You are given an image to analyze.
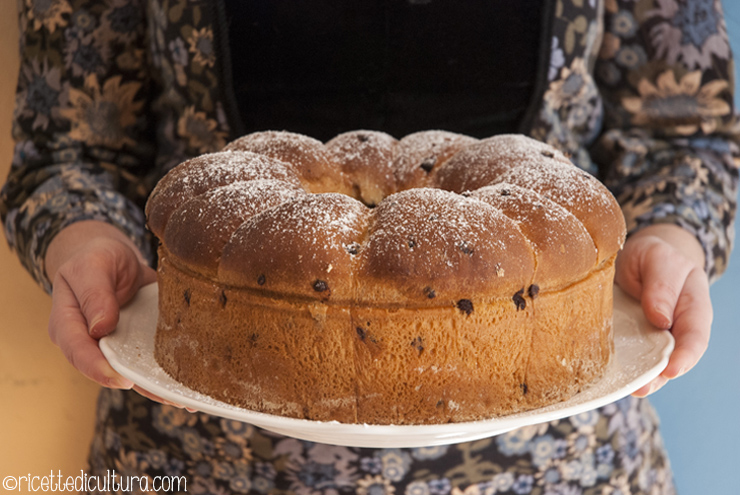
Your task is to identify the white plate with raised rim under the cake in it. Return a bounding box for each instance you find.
[100,284,674,447]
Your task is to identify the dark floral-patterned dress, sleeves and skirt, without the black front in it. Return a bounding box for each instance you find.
[0,0,740,495]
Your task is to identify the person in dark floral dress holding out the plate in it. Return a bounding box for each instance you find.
[0,0,740,495]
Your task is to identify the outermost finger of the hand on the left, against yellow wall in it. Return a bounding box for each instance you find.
[49,275,133,389]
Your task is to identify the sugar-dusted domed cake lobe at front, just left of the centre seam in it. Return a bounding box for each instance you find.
[219,193,369,302]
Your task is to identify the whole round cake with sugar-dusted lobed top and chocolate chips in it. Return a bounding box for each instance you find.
[146,130,625,424]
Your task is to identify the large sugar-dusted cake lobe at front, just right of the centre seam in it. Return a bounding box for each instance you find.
[356,188,535,305]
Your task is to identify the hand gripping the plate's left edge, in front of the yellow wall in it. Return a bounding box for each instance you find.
[46,220,189,407]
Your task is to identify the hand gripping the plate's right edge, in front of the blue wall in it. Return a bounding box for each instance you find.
[615,224,713,397]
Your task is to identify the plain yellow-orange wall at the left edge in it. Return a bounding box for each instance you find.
[0,0,98,476]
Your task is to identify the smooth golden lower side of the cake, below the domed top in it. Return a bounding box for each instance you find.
[155,248,614,424]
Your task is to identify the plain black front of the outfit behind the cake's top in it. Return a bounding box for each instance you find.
[224,0,542,141]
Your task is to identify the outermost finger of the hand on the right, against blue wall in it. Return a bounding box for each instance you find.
[663,268,713,378]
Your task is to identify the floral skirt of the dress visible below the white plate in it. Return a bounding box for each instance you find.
[90,389,675,495]
